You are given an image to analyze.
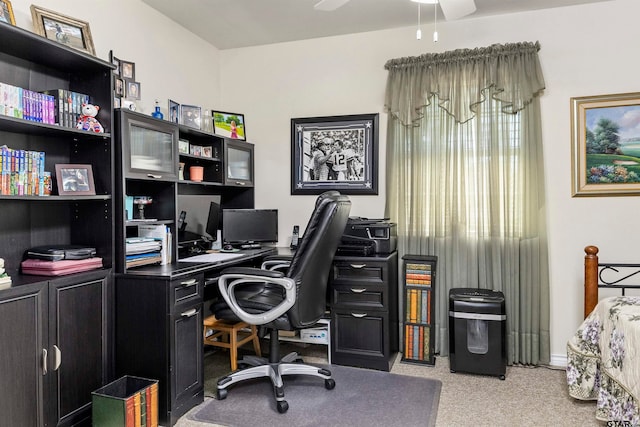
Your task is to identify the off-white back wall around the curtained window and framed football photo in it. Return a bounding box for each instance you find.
[220,0,640,362]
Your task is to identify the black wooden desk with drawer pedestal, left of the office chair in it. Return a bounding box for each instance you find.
[115,248,276,425]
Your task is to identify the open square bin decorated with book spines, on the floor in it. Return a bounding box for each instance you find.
[91,375,158,427]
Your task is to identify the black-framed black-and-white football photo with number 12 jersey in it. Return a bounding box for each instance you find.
[291,113,378,194]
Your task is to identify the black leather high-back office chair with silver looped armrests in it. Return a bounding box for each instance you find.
[212,194,351,413]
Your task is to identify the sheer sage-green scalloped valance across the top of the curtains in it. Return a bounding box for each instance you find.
[385,42,544,125]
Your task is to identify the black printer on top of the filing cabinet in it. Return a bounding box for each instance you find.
[336,217,398,256]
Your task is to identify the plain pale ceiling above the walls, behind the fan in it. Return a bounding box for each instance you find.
[142,0,611,49]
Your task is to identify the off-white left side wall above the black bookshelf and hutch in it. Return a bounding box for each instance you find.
[8,0,220,118]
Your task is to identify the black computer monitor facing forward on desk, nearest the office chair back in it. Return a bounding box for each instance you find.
[222,209,278,245]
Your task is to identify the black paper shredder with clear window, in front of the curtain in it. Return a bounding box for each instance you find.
[449,288,507,380]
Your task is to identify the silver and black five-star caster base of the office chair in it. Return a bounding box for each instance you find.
[216,329,336,414]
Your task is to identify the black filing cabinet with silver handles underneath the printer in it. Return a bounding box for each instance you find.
[328,252,399,371]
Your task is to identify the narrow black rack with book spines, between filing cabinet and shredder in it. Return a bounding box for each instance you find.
[402,255,438,365]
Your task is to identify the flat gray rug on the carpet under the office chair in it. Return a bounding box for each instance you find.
[191,365,442,427]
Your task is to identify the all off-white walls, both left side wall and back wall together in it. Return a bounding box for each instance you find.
[7,0,640,359]
